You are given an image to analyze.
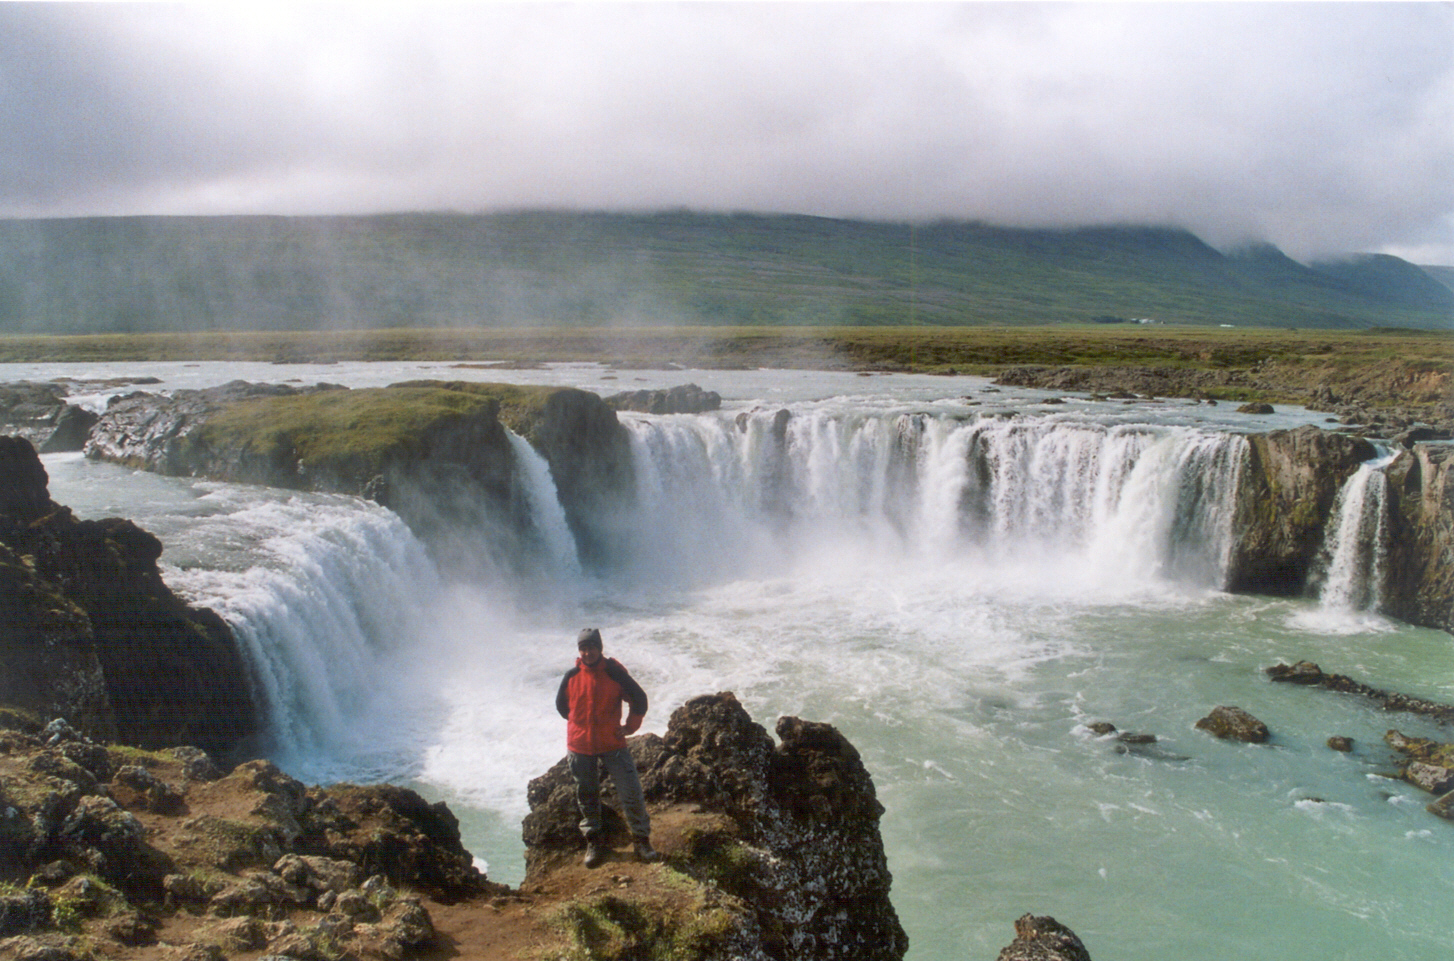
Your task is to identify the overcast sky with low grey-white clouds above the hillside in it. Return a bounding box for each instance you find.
[0,1,1454,263]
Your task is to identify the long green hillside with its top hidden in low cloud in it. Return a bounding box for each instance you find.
[0,212,1454,333]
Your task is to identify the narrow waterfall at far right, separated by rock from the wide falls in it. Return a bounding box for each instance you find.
[1314,454,1393,611]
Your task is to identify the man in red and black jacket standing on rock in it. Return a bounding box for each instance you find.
[555,628,657,868]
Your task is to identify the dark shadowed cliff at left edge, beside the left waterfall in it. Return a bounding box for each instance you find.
[0,438,257,752]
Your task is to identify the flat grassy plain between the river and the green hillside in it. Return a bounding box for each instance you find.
[0,324,1454,372]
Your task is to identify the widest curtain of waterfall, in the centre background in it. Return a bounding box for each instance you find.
[613,410,1246,587]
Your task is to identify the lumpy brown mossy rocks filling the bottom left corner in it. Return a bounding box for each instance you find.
[0,721,507,960]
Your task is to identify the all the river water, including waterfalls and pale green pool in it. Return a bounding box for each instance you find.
[14,363,1454,961]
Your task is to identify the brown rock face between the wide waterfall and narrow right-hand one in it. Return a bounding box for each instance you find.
[1226,426,1377,596]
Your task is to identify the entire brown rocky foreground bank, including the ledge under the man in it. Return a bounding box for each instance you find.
[0,693,936,961]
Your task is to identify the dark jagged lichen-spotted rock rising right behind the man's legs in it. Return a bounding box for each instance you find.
[523,693,907,961]
